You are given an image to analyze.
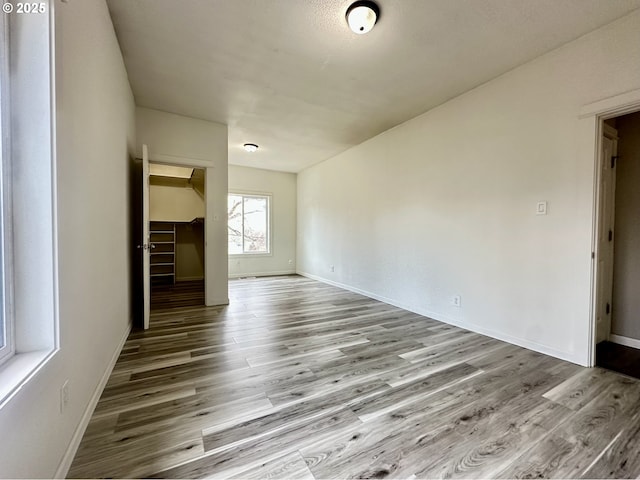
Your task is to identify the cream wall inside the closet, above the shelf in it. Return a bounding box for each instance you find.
[149,185,204,222]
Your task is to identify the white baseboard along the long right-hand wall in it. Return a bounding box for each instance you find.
[297,271,589,367]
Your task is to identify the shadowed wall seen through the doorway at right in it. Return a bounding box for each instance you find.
[611,113,640,340]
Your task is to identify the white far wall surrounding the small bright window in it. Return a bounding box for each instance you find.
[229,165,296,277]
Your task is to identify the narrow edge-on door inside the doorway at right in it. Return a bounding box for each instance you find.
[596,129,616,343]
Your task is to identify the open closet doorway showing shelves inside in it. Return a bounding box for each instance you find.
[149,163,206,311]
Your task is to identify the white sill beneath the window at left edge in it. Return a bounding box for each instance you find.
[0,350,55,409]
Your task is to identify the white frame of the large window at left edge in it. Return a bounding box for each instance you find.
[0,0,60,409]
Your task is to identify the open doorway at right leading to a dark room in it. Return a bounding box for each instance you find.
[595,112,640,378]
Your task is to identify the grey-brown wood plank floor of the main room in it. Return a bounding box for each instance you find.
[69,276,640,479]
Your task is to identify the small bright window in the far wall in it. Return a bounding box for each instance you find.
[228,193,271,255]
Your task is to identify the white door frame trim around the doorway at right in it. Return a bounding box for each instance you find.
[579,89,640,367]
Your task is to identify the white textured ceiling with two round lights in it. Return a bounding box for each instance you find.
[108,0,640,172]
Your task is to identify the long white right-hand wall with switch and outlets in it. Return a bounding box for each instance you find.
[297,11,640,364]
